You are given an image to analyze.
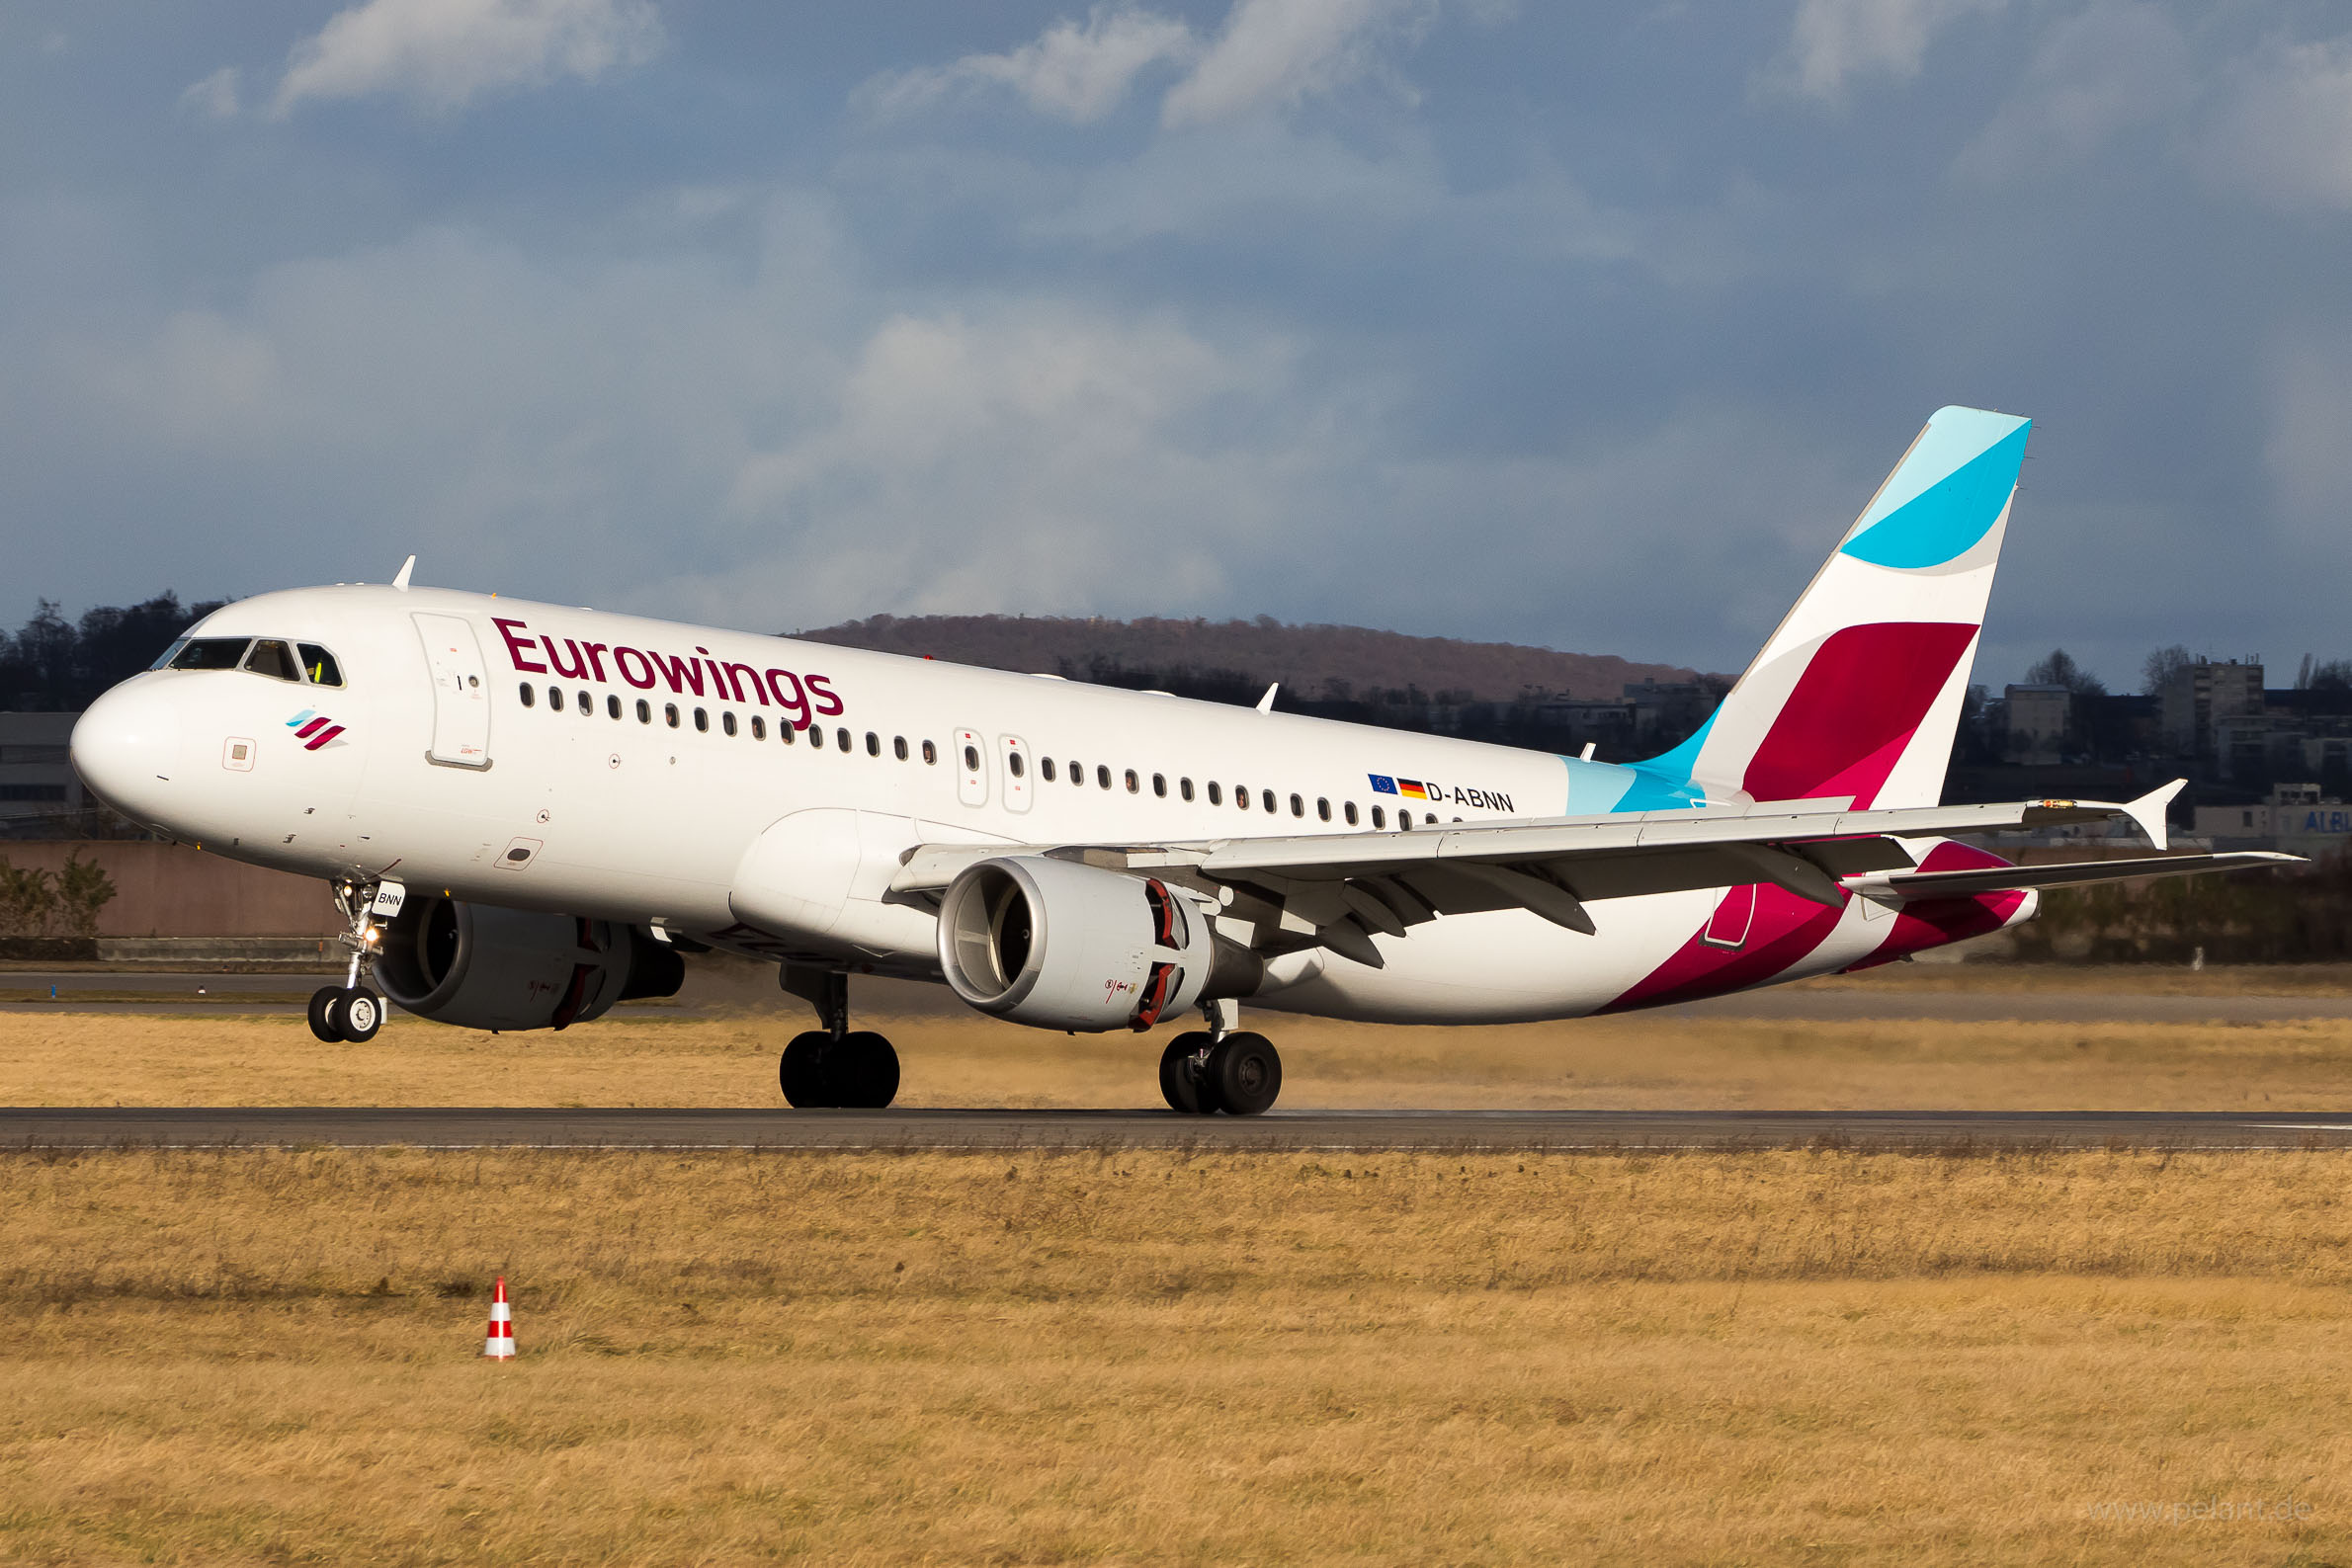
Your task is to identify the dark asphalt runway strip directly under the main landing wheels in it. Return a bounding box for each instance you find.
[0,1105,2352,1154]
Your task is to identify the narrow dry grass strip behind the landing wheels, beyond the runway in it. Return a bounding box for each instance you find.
[0,1013,2352,1110]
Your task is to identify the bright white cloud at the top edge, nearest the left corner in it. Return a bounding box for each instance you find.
[271,0,663,116]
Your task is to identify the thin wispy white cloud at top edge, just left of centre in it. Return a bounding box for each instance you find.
[861,5,1200,124]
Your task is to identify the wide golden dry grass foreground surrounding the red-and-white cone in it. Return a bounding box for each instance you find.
[0,1149,2352,1563]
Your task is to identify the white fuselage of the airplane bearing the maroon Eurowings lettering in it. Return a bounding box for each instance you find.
[75,585,1984,1023]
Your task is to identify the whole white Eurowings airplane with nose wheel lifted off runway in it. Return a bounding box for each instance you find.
[73,407,2296,1114]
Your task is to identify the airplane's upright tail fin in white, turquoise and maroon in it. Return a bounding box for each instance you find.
[1637,409,2032,806]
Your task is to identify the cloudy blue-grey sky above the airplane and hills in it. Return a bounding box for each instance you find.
[0,0,2352,689]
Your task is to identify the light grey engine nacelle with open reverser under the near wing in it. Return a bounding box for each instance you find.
[939,856,1216,1030]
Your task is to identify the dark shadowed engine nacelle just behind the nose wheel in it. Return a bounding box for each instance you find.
[377,893,687,1030]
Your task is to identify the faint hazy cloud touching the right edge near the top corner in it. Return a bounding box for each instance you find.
[2199,38,2352,211]
